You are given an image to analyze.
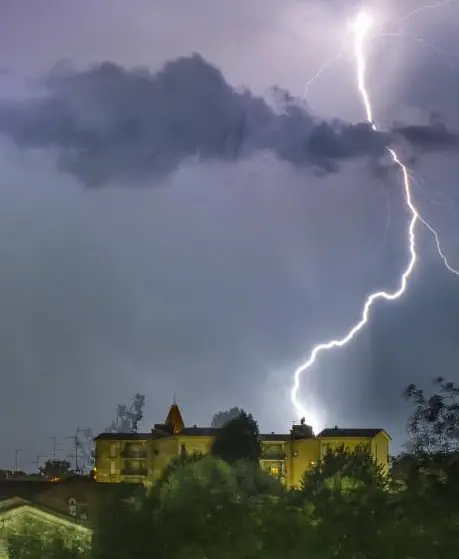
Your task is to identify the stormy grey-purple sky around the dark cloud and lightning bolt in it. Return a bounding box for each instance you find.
[0,0,459,468]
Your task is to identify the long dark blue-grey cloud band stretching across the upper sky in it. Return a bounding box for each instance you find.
[0,55,454,185]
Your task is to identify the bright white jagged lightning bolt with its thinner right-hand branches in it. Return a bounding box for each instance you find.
[290,7,459,424]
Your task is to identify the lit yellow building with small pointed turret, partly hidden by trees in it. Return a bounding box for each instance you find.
[95,404,390,487]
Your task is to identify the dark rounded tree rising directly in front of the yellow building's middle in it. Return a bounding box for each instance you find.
[212,411,261,464]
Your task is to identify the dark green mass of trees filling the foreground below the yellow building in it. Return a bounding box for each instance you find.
[10,390,459,559]
